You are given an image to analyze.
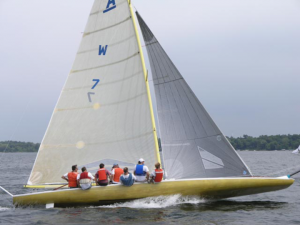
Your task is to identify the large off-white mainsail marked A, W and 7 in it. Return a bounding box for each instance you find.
[28,0,159,184]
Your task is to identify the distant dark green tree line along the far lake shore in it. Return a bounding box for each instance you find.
[0,134,300,152]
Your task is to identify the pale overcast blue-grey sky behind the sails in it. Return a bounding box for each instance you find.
[0,0,300,142]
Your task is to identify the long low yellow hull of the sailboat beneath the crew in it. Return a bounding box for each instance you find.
[13,177,294,206]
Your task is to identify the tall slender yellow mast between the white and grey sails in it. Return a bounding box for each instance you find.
[128,0,161,164]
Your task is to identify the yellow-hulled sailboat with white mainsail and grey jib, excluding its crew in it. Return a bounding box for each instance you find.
[1,0,294,206]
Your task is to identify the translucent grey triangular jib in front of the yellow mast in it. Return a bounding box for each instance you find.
[137,13,251,179]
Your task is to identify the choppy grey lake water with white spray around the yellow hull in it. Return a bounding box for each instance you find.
[0,151,300,225]
